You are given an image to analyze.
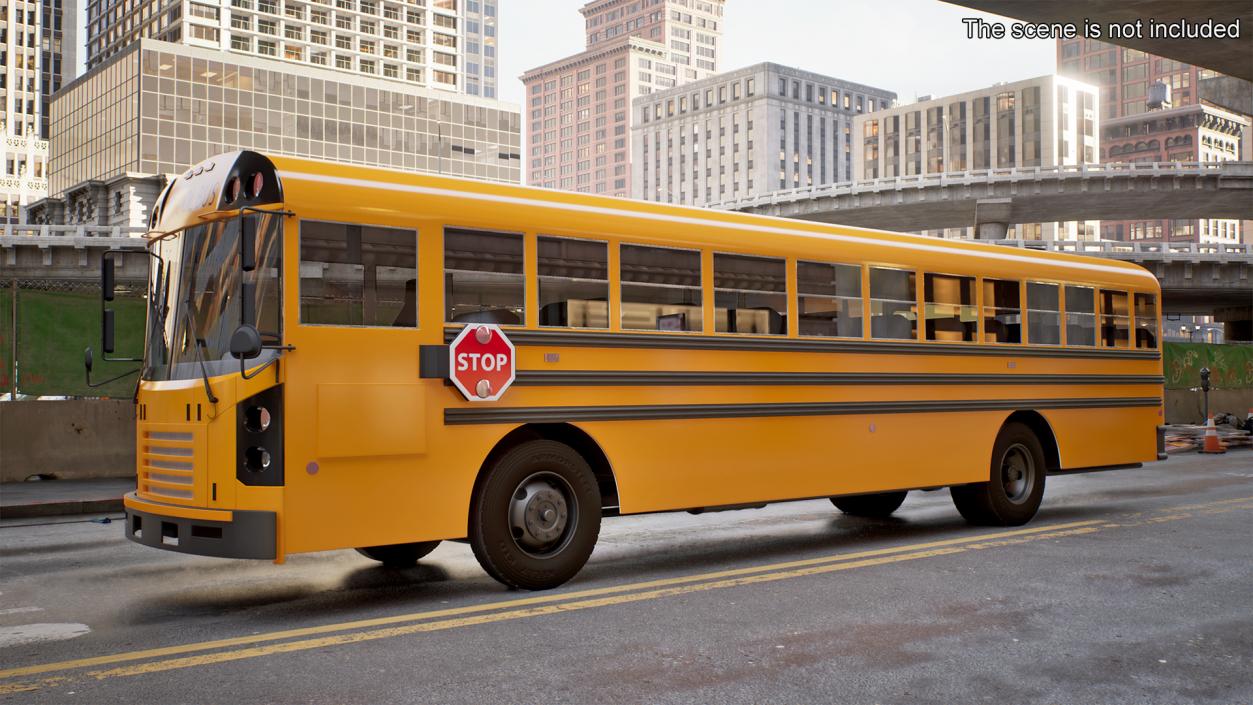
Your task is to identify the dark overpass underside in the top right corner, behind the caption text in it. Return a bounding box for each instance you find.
[946,0,1253,80]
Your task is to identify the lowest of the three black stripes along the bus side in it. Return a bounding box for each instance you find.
[444,397,1162,426]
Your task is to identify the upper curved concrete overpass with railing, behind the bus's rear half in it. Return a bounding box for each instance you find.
[713,162,1253,239]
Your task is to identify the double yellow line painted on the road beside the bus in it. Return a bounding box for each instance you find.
[0,497,1253,694]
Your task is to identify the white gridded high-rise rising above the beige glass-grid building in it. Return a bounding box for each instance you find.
[86,0,483,95]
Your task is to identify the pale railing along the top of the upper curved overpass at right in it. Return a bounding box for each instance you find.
[708,162,1253,210]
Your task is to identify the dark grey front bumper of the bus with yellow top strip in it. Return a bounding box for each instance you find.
[123,492,278,560]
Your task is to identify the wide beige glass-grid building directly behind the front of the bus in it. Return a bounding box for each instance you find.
[31,39,521,227]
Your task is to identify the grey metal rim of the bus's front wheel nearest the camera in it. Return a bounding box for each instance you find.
[509,472,579,558]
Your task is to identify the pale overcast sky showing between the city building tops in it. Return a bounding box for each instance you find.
[497,0,1056,104]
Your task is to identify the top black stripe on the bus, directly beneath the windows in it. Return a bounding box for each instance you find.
[444,327,1162,359]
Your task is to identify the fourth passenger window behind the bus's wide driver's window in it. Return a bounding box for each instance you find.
[713,253,787,336]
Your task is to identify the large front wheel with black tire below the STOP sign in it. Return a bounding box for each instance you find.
[469,441,600,590]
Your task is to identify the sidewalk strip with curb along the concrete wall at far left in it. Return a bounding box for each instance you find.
[0,477,135,518]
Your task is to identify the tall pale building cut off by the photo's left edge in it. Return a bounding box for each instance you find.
[0,0,78,223]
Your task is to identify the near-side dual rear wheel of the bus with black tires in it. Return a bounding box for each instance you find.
[949,423,1048,526]
